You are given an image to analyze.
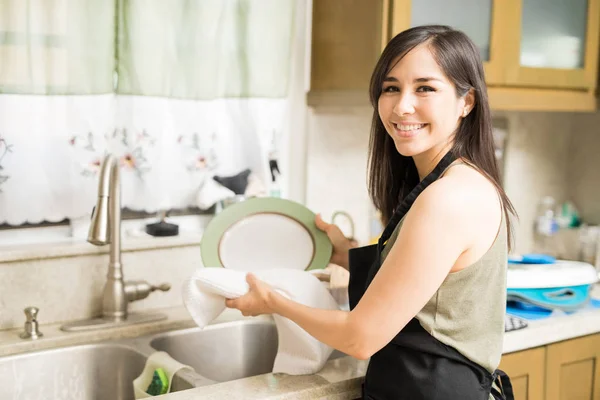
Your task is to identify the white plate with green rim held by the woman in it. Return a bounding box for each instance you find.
[200,197,332,271]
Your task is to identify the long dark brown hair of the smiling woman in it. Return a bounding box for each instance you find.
[368,25,516,248]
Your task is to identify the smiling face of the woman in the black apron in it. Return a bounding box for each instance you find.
[379,44,473,157]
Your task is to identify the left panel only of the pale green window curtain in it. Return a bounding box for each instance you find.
[0,0,116,95]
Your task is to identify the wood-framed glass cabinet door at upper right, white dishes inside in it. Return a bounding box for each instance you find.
[500,0,600,90]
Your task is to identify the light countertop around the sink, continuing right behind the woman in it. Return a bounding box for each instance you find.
[0,292,600,400]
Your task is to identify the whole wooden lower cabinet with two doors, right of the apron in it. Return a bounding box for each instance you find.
[500,334,600,400]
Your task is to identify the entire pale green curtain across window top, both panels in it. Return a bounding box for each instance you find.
[0,0,295,100]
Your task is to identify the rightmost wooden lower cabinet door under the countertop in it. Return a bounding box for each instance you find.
[546,335,600,400]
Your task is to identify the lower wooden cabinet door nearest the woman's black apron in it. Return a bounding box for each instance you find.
[500,347,546,400]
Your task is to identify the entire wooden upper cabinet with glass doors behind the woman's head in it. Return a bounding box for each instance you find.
[309,0,600,111]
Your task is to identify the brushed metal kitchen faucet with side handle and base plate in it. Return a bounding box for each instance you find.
[61,154,171,331]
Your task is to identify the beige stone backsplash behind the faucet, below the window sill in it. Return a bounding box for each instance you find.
[0,244,201,330]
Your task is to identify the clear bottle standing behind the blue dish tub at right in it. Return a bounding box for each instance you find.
[533,196,559,257]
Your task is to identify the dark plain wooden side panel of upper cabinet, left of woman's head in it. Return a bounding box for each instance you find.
[311,0,389,91]
